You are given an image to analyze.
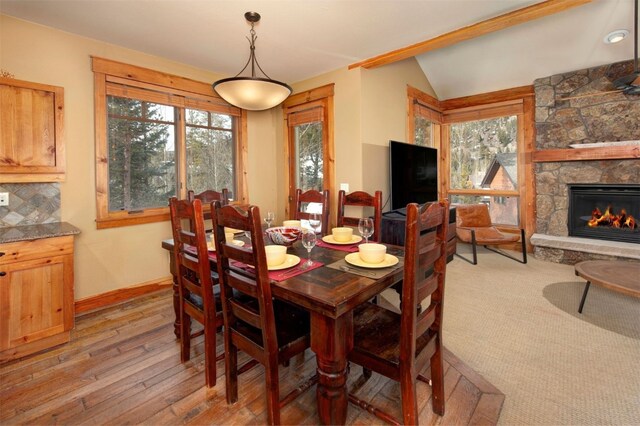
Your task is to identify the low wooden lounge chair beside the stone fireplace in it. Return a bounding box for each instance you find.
[456,204,527,265]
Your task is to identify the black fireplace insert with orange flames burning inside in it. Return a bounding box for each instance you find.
[568,184,640,244]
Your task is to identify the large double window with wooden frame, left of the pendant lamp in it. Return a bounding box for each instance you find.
[93,58,247,228]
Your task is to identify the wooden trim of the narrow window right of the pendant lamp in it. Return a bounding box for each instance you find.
[282,83,338,226]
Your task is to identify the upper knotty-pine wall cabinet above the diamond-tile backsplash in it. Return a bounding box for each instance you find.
[0,77,65,183]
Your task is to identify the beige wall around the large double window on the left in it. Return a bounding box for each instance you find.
[0,15,279,299]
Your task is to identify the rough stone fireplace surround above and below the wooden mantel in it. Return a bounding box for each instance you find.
[531,61,640,264]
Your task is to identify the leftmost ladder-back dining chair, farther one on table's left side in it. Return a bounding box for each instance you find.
[169,197,224,387]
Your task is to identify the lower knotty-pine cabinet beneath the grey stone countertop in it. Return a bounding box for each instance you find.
[0,236,74,362]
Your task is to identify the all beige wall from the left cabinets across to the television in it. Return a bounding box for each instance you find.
[0,16,433,299]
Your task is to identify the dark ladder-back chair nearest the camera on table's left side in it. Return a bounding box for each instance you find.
[212,202,317,424]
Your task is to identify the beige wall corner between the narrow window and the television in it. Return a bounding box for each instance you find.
[288,58,435,213]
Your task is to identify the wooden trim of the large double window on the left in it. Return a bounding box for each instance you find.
[92,57,249,229]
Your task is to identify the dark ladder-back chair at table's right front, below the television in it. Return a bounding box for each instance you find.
[349,200,449,425]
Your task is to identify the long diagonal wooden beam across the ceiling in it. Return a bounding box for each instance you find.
[349,0,593,69]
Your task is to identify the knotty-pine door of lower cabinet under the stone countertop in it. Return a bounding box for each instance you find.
[0,256,73,350]
